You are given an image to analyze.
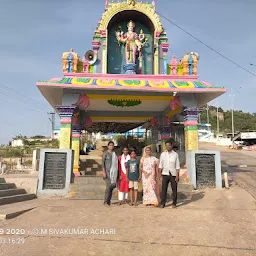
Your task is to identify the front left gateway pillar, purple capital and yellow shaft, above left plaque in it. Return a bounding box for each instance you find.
[56,106,76,149]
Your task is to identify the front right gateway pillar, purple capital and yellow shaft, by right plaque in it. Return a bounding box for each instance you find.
[184,108,200,151]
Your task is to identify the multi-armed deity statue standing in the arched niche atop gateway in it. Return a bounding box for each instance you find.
[116,20,148,64]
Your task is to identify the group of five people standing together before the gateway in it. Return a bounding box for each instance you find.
[102,140,180,208]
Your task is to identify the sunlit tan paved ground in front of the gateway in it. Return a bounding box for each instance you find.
[0,145,256,256]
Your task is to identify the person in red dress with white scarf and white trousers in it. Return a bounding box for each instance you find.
[118,147,130,205]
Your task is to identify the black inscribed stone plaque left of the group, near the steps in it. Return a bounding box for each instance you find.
[43,152,67,189]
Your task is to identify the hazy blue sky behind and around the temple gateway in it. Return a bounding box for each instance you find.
[0,0,256,144]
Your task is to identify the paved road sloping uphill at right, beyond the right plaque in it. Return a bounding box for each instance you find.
[200,143,256,199]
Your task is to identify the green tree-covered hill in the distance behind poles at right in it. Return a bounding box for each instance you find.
[201,106,256,133]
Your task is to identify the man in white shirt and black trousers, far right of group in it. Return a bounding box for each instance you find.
[158,140,180,208]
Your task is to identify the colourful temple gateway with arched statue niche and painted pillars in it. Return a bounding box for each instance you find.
[37,0,226,180]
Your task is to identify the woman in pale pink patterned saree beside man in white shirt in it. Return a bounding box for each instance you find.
[140,146,159,206]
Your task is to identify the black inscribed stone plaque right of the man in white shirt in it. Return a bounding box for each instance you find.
[195,154,216,187]
